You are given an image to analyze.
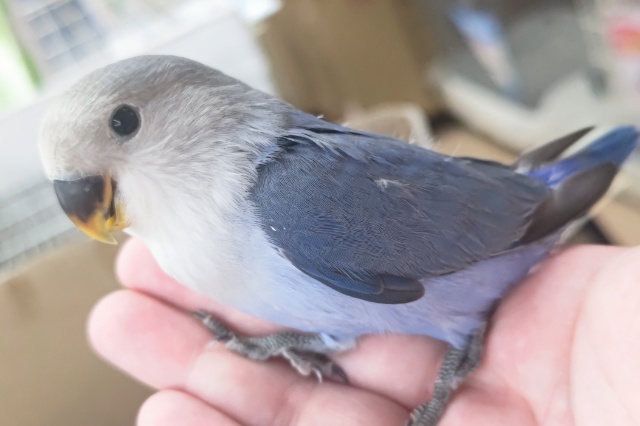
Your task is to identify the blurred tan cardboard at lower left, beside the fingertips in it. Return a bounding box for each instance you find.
[0,241,151,426]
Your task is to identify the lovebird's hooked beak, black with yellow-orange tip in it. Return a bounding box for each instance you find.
[53,176,129,244]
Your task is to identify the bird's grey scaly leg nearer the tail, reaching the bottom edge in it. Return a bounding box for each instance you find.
[406,328,485,426]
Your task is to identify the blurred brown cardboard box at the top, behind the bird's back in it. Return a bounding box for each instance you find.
[256,0,440,120]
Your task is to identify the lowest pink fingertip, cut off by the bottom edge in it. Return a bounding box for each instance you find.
[136,390,240,426]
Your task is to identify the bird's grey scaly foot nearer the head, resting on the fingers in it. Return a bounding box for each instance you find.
[192,311,350,383]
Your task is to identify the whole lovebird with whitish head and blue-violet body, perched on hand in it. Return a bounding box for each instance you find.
[39,56,638,426]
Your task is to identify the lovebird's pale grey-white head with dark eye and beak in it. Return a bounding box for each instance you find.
[39,56,283,243]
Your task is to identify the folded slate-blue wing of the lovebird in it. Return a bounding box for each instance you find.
[246,113,551,303]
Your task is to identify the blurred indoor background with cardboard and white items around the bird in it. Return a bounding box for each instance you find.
[0,0,640,426]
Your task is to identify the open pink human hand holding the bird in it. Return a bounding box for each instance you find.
[90,240,640,426]
